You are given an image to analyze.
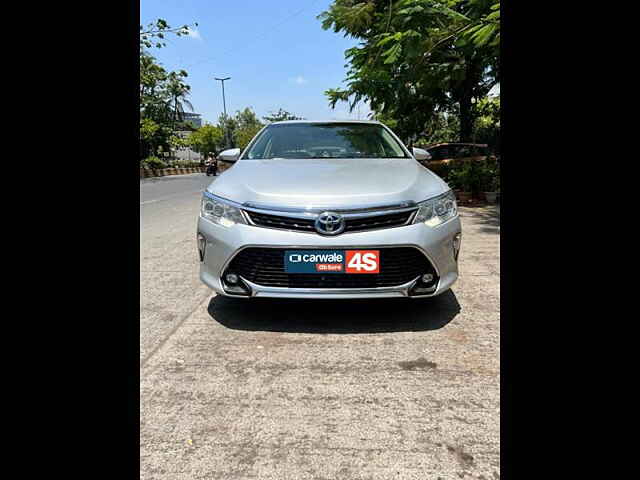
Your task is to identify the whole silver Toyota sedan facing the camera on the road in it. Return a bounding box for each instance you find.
[197,121,461,299]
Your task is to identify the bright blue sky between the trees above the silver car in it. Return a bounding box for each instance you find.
[140,0,370,123]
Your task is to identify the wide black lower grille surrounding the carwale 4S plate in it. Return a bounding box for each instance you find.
[224,247,437,288]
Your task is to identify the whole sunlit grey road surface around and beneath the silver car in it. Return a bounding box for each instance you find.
[140,174,500,480]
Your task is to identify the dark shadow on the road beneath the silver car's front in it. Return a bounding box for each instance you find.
[207,290,460,334]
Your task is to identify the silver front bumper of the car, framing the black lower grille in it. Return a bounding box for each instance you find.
[198,217,461,299]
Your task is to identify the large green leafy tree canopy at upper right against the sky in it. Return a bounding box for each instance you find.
[318,0,500,141]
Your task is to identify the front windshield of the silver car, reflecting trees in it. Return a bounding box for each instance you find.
[242,123,408,160]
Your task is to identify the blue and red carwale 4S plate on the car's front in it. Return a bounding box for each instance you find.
[284,250,380,273]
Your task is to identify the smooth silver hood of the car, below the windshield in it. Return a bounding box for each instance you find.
[207,158,448,208]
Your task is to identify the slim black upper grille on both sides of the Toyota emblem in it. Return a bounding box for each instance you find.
[246,210,415,232]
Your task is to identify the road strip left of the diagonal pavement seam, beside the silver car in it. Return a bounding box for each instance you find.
[140,173,211,364]
